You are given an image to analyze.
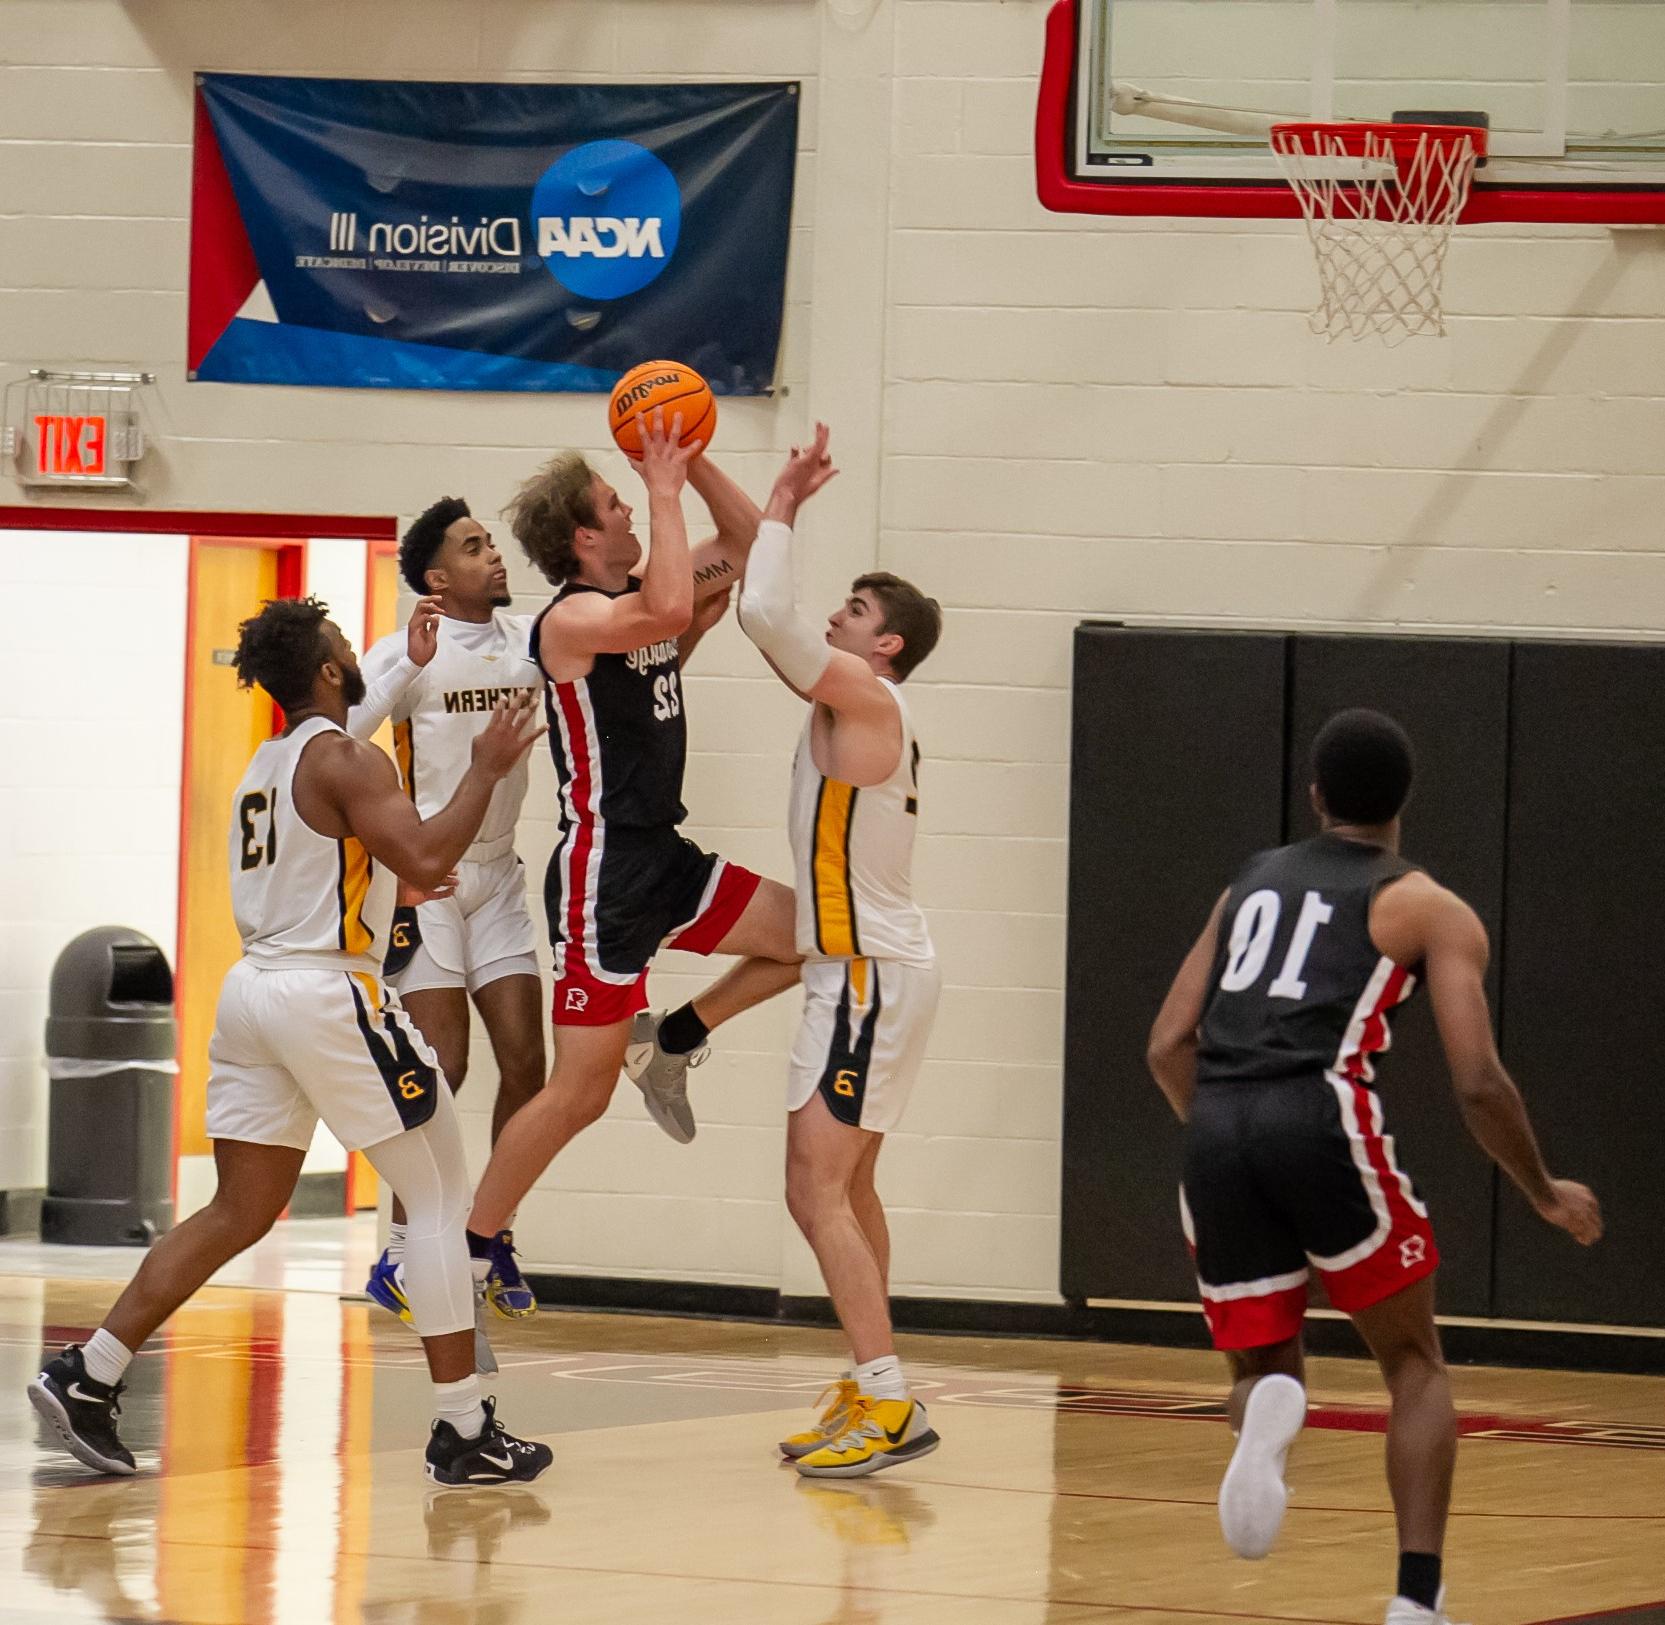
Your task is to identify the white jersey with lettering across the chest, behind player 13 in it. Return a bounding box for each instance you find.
[365,609,543,862]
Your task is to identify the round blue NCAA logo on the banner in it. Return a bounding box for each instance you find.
[531,142,683,300]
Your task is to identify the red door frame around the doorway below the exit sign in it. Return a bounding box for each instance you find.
[0,504,398,1202]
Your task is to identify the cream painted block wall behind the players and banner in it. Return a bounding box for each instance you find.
[0,0,1665,1297]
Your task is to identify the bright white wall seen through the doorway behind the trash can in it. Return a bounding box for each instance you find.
[0,529,188,1190]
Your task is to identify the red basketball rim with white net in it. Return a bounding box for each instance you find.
[1272,122,1485,345]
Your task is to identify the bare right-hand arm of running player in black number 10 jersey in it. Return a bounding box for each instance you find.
[1370,874,1602,1247]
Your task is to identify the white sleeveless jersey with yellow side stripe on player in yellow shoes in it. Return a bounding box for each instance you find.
[788,679,936,964]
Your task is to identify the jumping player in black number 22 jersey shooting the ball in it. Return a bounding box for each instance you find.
[470,415,799,1252]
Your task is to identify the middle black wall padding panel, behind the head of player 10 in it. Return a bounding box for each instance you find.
[1285,636,1510,1315]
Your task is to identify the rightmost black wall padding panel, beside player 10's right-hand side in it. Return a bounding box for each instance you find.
[1497,643,1665,1325]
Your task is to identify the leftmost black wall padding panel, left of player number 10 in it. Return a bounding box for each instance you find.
[1061,624,1287,1299]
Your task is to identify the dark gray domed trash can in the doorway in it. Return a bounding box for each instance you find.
[40,926,178,1247]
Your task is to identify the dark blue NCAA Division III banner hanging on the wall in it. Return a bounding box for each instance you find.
[188,73,799,395]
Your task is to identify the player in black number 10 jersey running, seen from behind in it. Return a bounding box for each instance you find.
[1149,711,1602,1625]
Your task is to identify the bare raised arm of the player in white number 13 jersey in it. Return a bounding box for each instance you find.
[295,693,544,891]
